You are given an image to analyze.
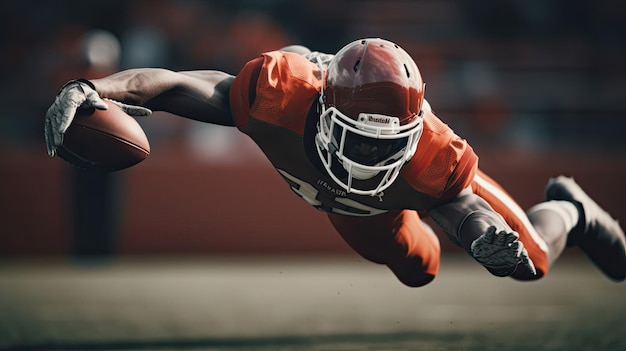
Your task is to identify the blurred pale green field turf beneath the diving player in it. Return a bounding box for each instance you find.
[0,252,626,351]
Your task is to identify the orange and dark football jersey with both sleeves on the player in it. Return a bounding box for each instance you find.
[230,51,478,215]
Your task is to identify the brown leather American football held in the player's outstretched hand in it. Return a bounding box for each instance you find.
[58,101,150,172]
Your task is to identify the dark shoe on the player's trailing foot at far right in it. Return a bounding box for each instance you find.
[545,176,626,281]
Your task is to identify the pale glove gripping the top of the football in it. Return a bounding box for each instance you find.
[44,80,152,157]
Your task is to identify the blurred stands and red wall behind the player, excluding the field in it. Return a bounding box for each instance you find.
[0,0,626,257]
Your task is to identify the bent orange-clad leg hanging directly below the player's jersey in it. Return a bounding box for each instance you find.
[328,210,441,287]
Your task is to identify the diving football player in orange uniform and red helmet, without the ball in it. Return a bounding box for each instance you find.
[45,38,626,287]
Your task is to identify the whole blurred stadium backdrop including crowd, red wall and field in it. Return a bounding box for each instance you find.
[0,0,626,351]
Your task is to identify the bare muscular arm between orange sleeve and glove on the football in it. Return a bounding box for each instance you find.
[91,68,234,126]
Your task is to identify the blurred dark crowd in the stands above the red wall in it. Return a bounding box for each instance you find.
[0,0,626,153]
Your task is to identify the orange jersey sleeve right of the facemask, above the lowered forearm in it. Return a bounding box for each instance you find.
[401,112,478,203]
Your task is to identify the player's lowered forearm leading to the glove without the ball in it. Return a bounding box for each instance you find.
[428,189,512,252]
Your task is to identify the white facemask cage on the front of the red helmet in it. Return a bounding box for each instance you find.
[315,105,423,196]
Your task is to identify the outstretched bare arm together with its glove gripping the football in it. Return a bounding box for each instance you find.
[44,68,234,156]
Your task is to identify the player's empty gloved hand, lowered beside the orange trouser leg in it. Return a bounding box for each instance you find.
[471,226,537,277]
